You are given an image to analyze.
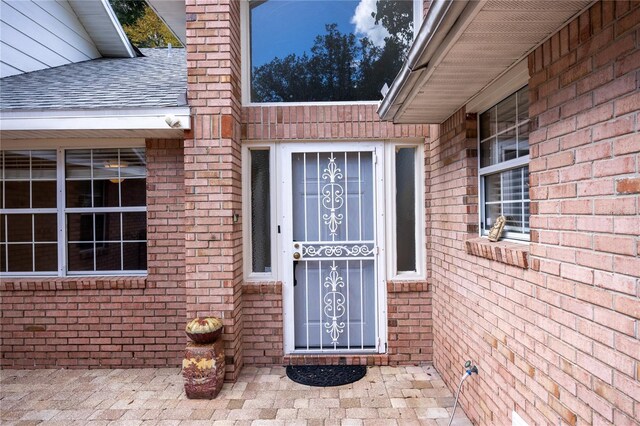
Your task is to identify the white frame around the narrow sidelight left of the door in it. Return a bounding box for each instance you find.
[242,142,281,282]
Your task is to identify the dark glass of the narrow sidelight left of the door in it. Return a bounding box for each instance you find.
[251,150,271,273]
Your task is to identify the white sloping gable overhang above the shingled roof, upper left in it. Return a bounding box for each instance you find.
[69,0,136,58]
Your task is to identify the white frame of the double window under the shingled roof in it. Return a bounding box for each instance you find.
[0,138,148,278]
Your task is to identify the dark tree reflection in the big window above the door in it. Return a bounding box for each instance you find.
[251,0,413,102]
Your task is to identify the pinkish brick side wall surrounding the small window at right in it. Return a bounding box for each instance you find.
[429,1,640,425]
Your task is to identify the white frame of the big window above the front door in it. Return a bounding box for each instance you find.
[240,0,424,106]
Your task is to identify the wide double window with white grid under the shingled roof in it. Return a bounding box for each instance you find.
[0,148,147,276]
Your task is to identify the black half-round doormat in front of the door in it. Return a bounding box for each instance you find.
[287,365,367,387]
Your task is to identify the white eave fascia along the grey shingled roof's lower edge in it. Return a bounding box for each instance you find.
[0,107,191,140]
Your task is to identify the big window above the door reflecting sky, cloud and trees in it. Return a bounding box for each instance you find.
[245,0,421,102]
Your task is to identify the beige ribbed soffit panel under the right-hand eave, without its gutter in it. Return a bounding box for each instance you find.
[379,0,593,123]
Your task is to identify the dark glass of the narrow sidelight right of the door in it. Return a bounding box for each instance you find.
[396,147,416,272]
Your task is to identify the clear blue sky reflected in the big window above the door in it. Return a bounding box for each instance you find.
[251,0,362,67]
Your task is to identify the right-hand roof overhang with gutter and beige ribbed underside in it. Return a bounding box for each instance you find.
[378,0,593,123]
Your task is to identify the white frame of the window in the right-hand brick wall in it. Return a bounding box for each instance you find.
[477,88,531,242]
